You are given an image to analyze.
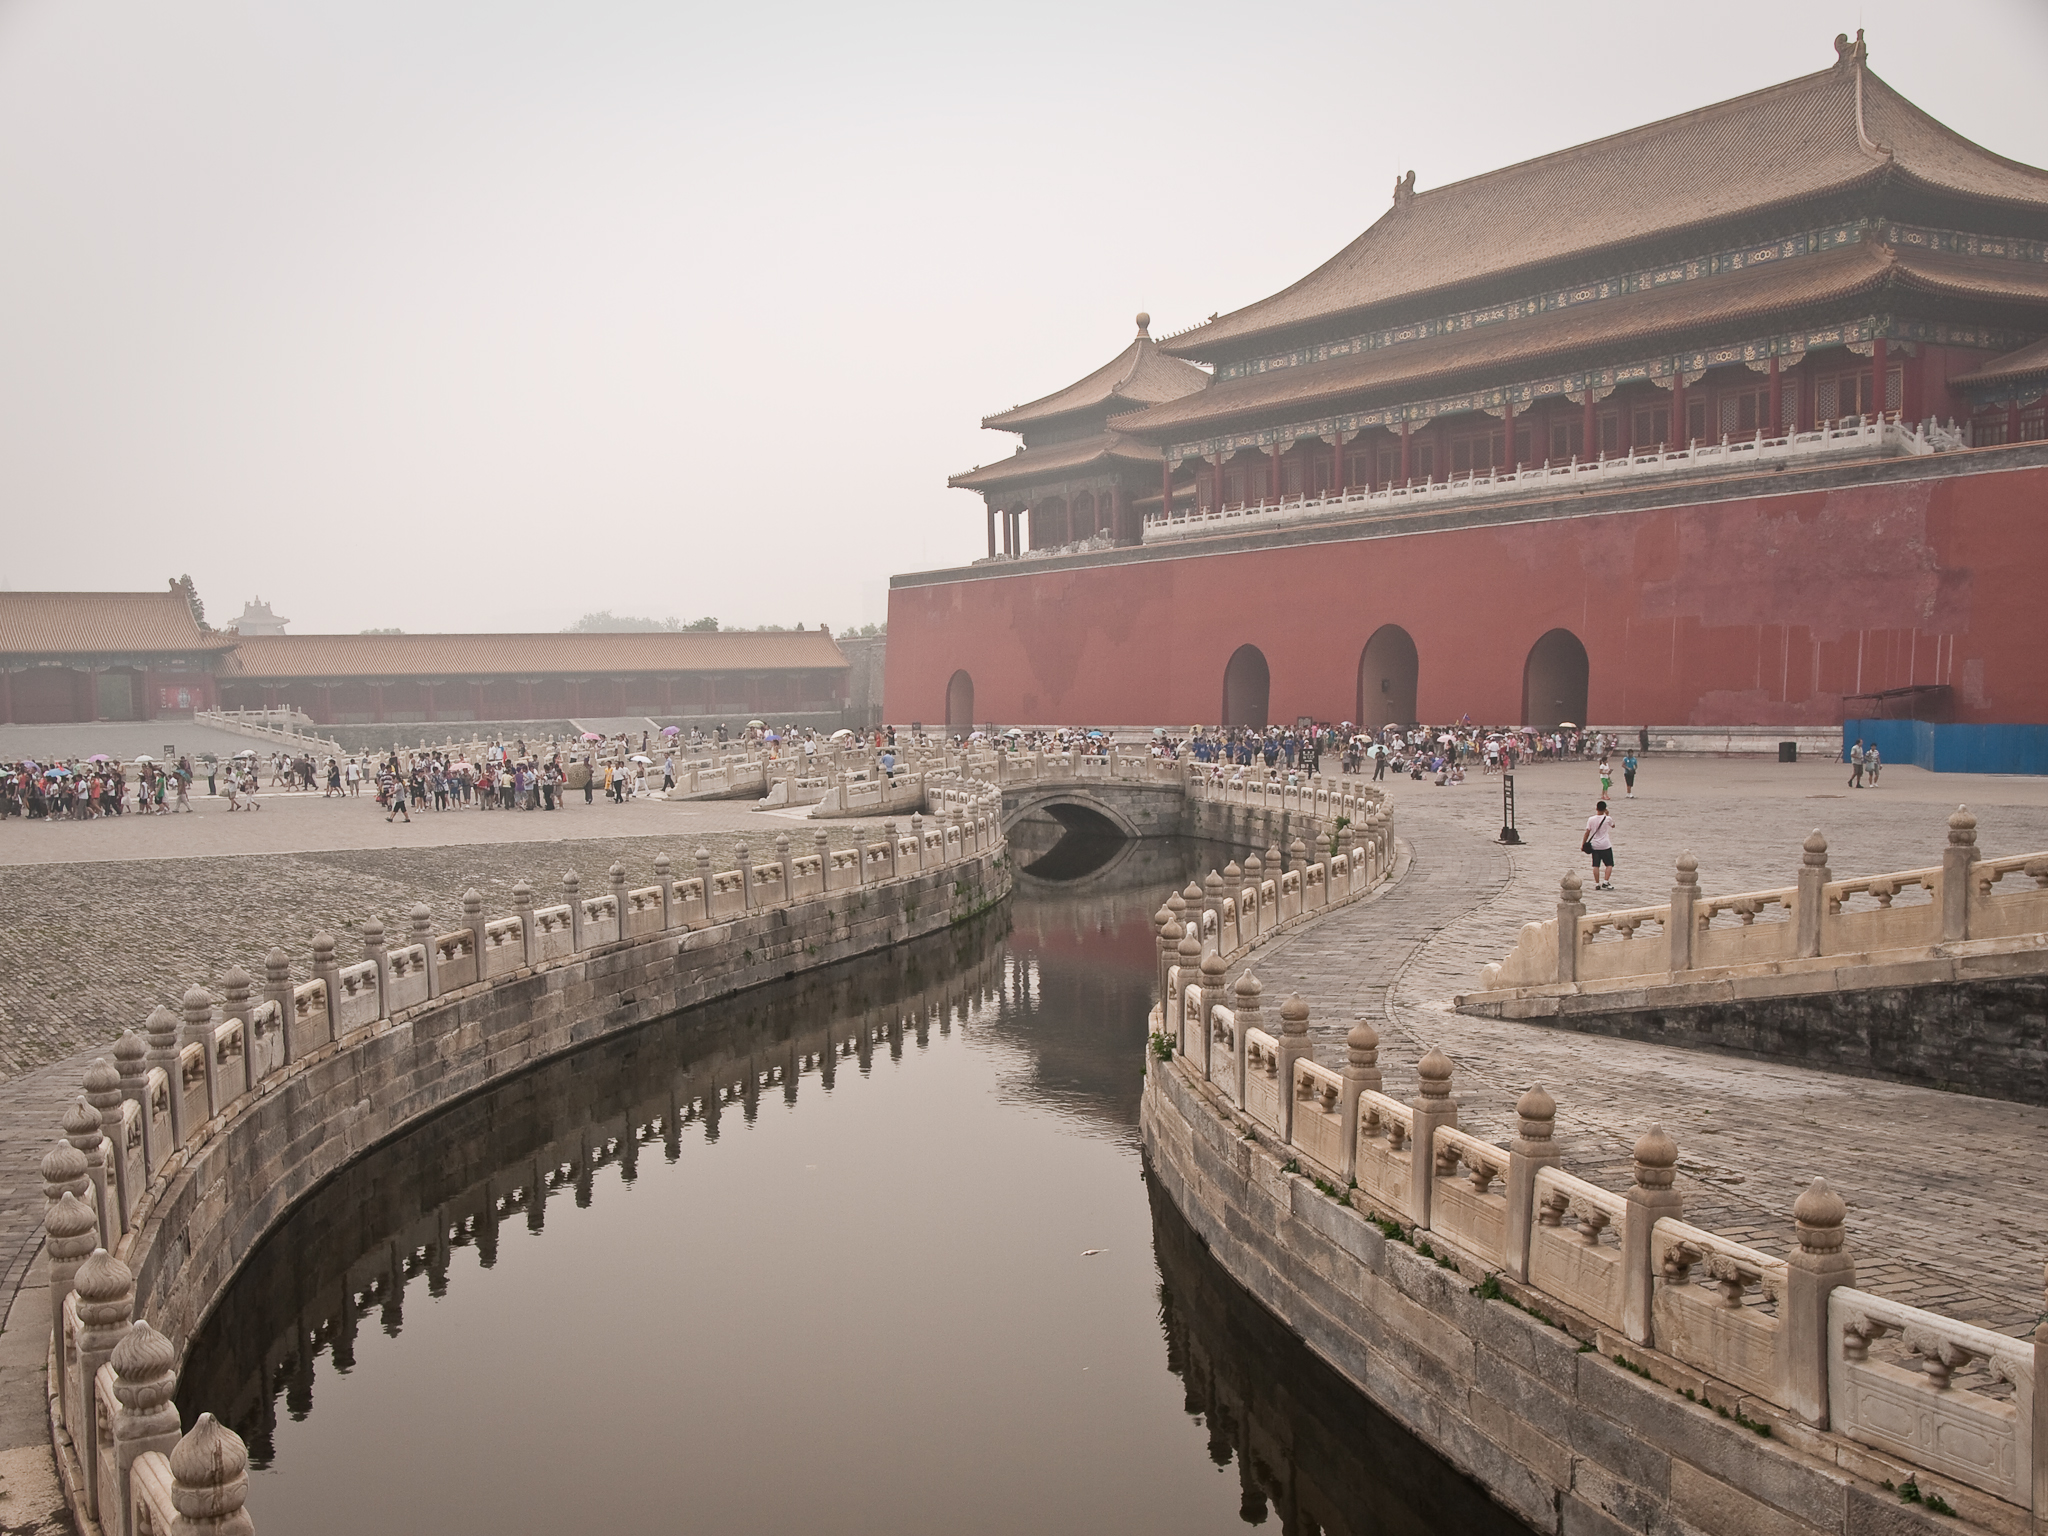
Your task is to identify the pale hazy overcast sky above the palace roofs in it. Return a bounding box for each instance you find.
[0,0,2048,633]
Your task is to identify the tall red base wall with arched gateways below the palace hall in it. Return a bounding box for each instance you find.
[887,465,2048,727]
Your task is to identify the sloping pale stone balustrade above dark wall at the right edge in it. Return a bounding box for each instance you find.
[1458,807,2048,1104]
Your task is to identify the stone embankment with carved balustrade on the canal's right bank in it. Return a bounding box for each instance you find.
[1141,848,2048,1536]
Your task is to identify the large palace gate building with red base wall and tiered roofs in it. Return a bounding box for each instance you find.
[905,35,2048,727]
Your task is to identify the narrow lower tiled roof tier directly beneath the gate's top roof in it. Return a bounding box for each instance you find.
[1116,244,2023,440]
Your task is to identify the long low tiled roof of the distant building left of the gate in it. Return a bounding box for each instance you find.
[221,629,846,678]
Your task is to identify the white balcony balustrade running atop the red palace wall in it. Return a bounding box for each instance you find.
[1138,416,1968,555]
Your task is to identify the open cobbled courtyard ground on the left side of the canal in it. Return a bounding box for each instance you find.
[0,795,897,1079]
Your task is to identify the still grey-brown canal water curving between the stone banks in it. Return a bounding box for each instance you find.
[180,827,1522,1536]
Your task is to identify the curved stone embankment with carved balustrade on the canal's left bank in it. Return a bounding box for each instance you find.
[43,780,1010,1536]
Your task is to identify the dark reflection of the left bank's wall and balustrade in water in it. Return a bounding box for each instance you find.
[178,915,1018,1466]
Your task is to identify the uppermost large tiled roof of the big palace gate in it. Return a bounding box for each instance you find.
[1167,47,2048,356]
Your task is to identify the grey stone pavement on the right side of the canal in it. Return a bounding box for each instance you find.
[1220,758,2048,1333]
